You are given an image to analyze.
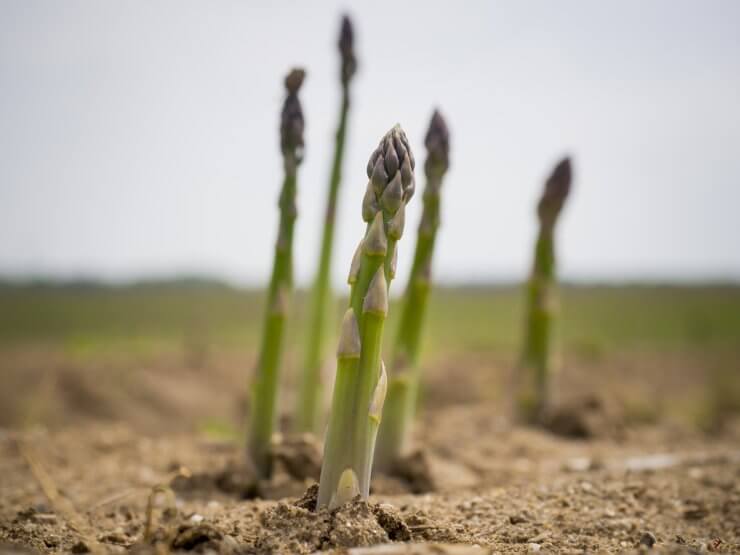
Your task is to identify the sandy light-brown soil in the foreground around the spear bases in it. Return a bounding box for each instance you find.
[0,416,740,555]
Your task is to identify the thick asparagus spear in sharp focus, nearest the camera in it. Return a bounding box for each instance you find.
[318,125,415,507]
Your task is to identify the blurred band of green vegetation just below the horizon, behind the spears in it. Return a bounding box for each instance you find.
[0,281,740,359]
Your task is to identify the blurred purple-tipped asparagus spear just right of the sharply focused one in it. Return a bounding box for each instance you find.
[376,110,450,471]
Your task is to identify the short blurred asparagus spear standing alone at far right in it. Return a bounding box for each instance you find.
[517,158,572,423]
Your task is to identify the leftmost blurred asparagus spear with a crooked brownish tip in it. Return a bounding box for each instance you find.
[247,69,305,477]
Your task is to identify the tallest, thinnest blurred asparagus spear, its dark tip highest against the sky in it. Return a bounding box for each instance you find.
[295,16,357,432]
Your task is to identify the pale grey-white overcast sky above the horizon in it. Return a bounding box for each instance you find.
[0,0,740,285]
